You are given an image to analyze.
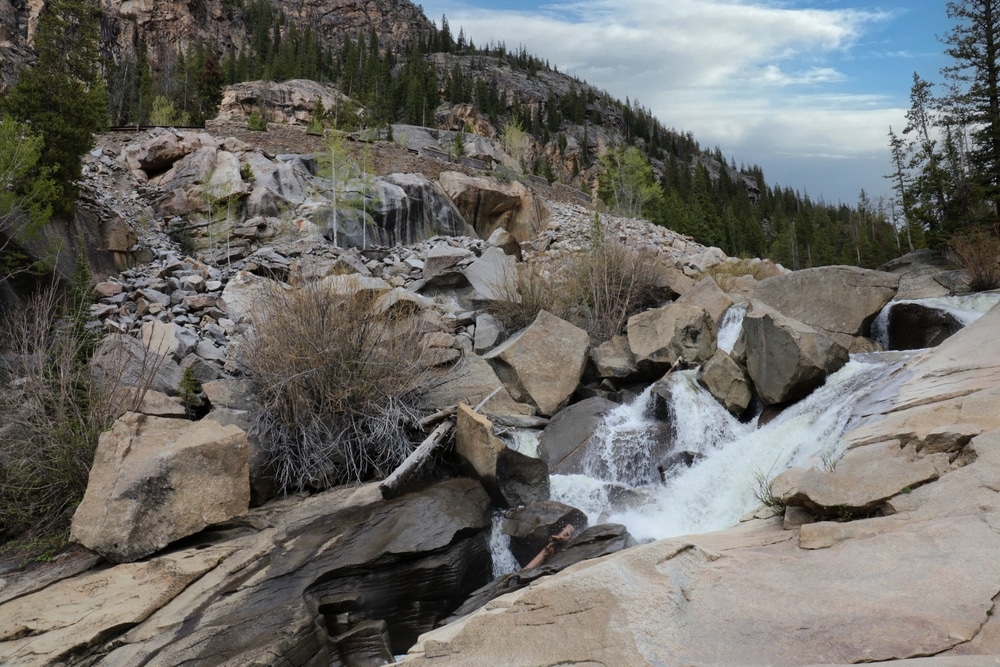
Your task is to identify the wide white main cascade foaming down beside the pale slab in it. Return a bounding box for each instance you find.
[552,354,908,540]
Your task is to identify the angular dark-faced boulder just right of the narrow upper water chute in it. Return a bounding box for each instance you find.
[743,303,849,405]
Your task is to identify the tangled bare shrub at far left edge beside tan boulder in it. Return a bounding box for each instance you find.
[0,289,148,552]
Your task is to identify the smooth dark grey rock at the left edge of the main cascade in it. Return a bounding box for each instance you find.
[538,397,618,475]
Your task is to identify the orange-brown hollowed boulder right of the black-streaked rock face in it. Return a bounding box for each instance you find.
[438,171,544,242]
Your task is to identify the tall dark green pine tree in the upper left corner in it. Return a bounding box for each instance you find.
[0,0,108,216]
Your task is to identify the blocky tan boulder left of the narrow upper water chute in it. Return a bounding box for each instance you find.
[627,303,715,375]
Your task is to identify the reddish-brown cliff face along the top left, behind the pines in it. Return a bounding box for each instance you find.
[0,0,431,88]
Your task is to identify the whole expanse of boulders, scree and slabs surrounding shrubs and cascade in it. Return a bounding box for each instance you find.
[0,124,1000,667]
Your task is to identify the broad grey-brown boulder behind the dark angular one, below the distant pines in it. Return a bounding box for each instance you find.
[754,266,899,348]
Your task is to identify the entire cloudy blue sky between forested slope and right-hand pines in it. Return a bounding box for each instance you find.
[421,0,951,204]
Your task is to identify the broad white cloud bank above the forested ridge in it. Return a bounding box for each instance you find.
[425,0,902,200]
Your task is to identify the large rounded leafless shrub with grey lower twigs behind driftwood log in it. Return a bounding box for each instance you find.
[241,281,429,491]
